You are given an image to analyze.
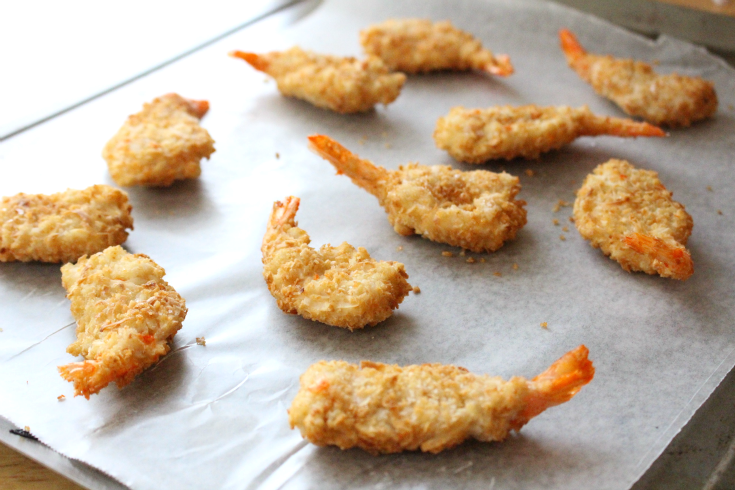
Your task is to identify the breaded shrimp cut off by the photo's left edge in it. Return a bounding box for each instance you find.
[0,185,133,262]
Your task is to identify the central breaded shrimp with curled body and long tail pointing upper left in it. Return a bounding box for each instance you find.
[309,135,526,252]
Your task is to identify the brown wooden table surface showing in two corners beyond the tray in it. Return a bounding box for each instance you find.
[0,0,735,490]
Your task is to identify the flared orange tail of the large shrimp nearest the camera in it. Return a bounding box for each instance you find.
[511,345,595,430]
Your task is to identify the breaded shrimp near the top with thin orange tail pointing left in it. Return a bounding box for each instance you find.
[230,47,406,114]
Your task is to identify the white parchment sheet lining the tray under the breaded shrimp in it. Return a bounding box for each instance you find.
[0,0,735,489]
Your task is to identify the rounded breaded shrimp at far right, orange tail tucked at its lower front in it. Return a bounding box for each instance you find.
[574,160,694,280]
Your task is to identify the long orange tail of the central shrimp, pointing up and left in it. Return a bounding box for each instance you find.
[309,134,388,199]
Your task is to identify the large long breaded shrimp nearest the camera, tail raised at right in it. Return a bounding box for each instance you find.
[288,345,595,454]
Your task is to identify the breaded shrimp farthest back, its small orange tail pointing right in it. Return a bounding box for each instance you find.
[360,19,513,77]
